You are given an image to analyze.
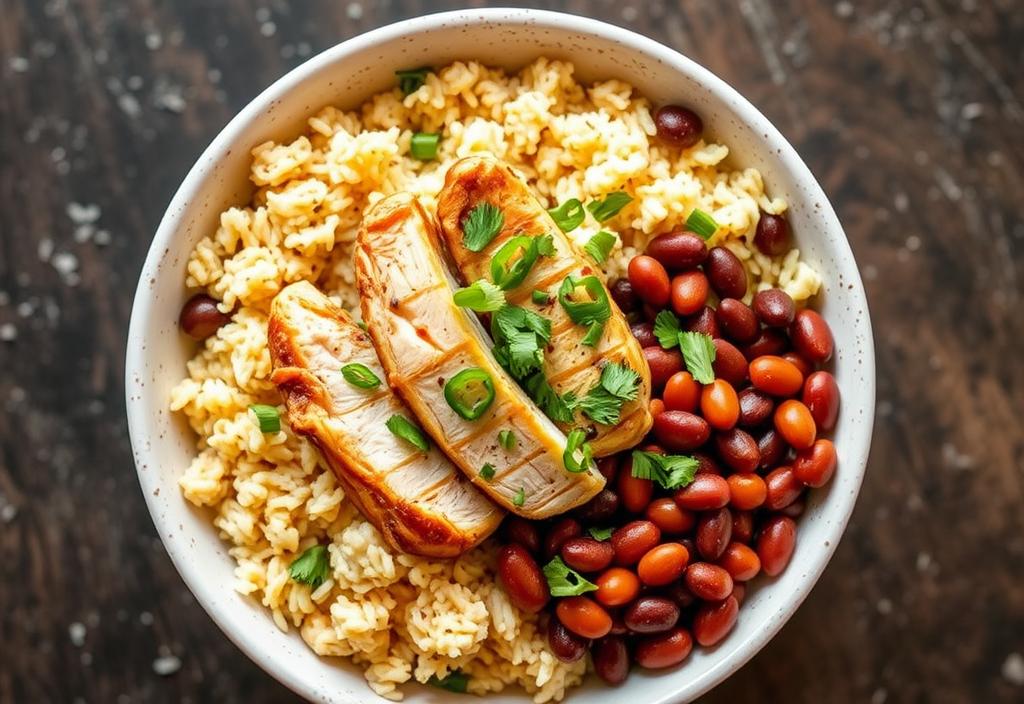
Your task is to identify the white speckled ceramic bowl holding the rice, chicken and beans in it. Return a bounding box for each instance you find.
[126,9,874,704]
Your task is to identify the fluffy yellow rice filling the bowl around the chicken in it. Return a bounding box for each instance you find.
[170,58,820,703]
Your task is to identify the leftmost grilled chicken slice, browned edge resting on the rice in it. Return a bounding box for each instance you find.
[268,281,503,558]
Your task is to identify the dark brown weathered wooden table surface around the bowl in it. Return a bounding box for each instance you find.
[0,0,1024,704]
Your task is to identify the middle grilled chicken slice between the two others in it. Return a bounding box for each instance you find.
[354,193,604,519]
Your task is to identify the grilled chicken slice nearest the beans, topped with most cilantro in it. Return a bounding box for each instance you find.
[437,157,651,456]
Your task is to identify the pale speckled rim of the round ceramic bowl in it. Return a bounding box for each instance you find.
[125,8,874,704]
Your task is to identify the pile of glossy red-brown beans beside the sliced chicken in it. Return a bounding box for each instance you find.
[499,216,839,685]
